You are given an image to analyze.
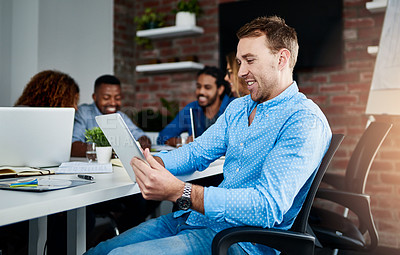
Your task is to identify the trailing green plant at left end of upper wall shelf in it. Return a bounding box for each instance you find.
[134,8,165,49]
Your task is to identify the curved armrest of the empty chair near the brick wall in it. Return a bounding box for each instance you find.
[315,189,379,247]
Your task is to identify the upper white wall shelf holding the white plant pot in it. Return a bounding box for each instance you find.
[136,26,204,39]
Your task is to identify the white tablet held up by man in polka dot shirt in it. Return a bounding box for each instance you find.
[96,113,146,183]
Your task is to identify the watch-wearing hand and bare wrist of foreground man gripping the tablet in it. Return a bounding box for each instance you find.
[131,149,204,214]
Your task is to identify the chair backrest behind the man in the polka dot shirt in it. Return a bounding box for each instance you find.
[291,134,344,233]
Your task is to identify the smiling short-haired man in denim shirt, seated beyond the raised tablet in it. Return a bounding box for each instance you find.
[71,75,151,157]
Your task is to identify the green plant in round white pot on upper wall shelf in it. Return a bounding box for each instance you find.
[173,0,202,26]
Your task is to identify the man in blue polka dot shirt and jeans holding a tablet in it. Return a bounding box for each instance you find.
[87,16,332,255]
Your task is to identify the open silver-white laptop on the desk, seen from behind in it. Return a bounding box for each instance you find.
[0,107,75,167]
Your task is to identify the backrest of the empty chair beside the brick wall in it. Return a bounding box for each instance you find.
[345,122,393,193]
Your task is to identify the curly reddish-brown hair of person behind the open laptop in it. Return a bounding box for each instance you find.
[15,70,79,109]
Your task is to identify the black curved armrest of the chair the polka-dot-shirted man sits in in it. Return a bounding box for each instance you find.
[212,227,315,255]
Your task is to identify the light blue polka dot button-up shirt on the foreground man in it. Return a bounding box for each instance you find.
[157,82,332,254]
